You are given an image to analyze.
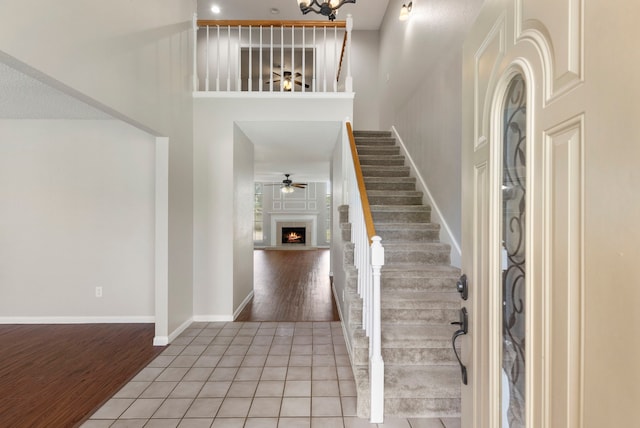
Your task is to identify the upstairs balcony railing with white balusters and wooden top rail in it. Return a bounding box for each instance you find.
[193,15,353,93]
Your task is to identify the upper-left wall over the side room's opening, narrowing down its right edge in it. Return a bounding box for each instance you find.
[0,0,196,335]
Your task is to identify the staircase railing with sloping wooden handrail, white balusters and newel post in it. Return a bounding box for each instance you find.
[345,122,384,423]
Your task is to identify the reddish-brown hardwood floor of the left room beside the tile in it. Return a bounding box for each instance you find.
[0,324,164,428]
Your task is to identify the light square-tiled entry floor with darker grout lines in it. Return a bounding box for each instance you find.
[82,322,460,428]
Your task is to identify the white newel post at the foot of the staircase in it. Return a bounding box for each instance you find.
[369,236,384,424]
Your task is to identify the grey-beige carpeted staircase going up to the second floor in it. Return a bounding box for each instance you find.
[340,131,460,418]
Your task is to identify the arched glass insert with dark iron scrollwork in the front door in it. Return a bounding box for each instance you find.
[502,75,527,428]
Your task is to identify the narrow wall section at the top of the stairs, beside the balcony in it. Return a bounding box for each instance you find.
[351,31,380,130]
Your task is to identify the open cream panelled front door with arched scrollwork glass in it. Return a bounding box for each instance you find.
[462,0,584,428]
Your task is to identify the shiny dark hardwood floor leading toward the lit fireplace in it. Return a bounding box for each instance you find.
[236,249,340,321]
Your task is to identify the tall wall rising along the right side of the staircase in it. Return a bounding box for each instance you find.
[378,0,482,254]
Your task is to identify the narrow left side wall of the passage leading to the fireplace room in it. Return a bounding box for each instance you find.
[233,125,255,313]
